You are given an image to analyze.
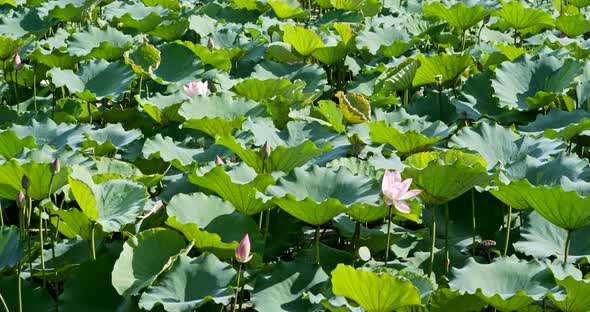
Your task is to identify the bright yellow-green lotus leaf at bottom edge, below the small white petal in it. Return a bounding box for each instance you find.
[332,264,420,312]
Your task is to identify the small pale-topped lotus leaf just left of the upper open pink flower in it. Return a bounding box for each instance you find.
[139,92,186,126]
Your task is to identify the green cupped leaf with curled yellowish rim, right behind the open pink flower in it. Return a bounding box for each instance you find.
[402,150,489,206]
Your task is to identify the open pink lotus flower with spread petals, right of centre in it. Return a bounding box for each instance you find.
[381,170,422,213]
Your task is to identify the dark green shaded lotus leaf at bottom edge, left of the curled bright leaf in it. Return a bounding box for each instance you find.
[59,253,129,312]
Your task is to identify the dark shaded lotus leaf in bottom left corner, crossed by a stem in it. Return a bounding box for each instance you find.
[0,275,55,312]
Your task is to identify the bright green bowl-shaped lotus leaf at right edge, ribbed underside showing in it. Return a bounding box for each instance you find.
[511,178,590,230]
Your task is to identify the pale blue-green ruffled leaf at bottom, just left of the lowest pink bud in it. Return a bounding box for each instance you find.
[139,254,237,312]
